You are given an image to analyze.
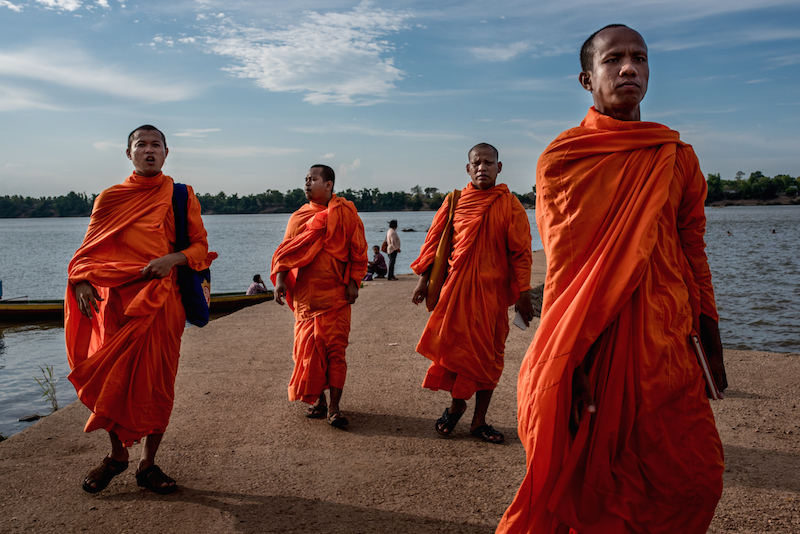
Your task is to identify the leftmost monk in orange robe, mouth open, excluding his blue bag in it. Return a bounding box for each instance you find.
[64,125,217,493]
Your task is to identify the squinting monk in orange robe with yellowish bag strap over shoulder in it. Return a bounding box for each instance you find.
[411,143,533,443]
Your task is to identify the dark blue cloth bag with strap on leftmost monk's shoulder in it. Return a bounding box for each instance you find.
[172,183,211,326]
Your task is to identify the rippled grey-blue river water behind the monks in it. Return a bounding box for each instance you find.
[0,206,800,436]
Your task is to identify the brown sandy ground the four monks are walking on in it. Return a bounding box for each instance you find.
[0,253,800,534]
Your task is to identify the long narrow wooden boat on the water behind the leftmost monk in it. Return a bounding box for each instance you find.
[0,291,274,323]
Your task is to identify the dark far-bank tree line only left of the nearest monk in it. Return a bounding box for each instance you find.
[0,185,535,218]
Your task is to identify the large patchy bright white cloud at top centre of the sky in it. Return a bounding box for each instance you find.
[200,1,410,104]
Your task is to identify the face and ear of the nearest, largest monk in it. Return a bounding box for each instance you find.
[580,27,650,121]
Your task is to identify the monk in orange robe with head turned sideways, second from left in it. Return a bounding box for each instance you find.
[271,165,367,428]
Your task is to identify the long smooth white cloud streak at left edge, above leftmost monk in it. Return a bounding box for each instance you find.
[0,46,197,102]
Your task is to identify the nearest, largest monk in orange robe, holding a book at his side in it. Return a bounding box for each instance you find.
[497,25,727,534]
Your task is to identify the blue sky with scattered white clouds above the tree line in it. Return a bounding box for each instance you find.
[0,0,800,196]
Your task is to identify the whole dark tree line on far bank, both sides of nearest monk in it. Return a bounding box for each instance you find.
[0,171,800,218]
